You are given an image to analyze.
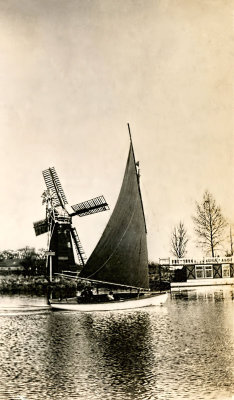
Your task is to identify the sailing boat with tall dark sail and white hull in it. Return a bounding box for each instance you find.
[50,125,168,311]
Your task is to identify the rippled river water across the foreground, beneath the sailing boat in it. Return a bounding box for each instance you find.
[0,286,234,400]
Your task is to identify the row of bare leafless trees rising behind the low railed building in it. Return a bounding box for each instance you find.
[171,191,233,258]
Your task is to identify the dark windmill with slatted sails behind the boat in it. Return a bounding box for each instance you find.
[33,167,109,272]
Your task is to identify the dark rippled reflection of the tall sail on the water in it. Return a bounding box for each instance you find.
[79,312,154,398]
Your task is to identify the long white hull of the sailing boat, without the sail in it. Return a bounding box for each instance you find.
[50,293,168,312]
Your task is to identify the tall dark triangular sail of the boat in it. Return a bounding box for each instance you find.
[80,143,149,289]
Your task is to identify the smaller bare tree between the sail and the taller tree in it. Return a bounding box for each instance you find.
[171,221,188,258]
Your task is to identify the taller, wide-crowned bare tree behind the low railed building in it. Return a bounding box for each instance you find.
[193,191,227,257]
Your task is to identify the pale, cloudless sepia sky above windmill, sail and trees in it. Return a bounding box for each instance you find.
[0,0,234,261]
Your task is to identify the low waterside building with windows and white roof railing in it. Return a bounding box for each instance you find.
[159,257,234,288]
